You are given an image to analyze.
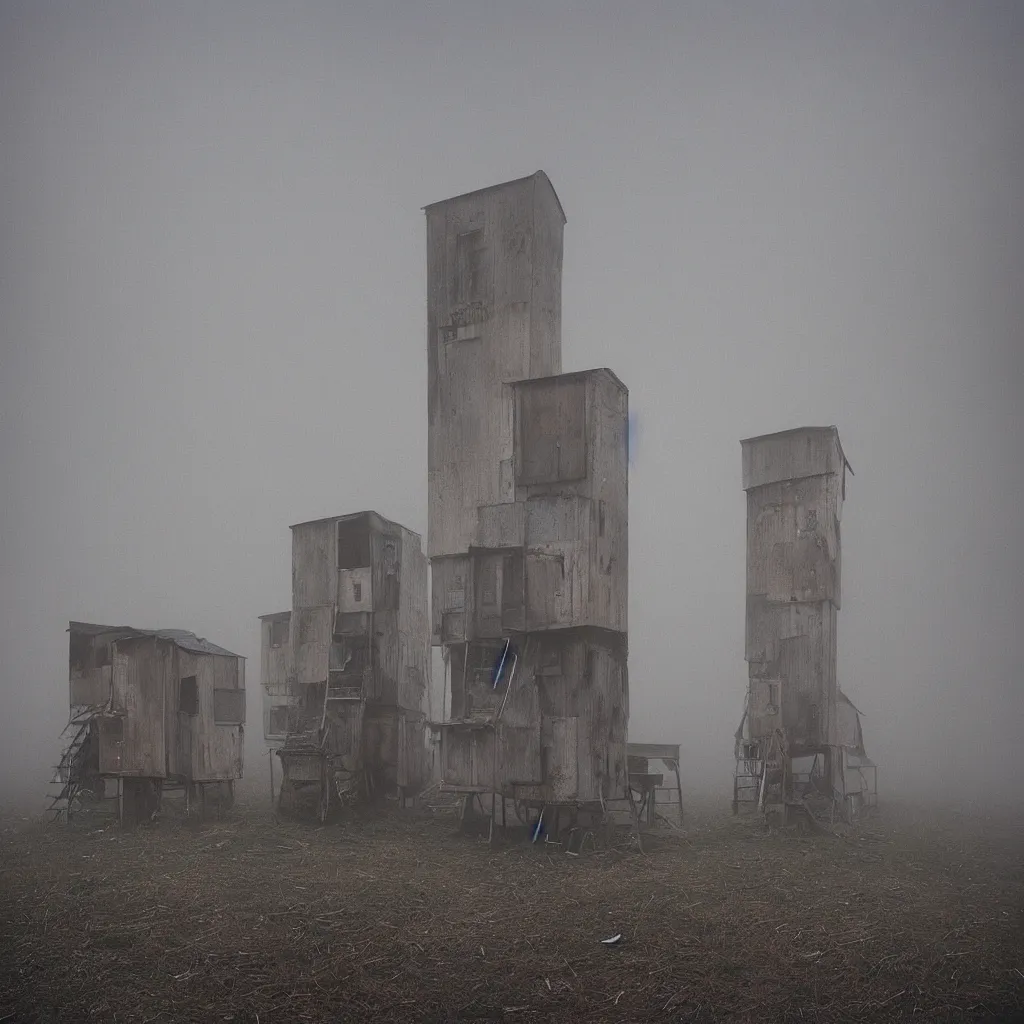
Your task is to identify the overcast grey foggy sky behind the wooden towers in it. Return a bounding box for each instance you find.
[0,0,1024,802]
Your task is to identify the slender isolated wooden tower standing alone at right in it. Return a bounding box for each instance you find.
[734,427,852,816]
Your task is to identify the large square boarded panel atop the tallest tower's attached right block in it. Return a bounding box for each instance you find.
[516,380,587,484]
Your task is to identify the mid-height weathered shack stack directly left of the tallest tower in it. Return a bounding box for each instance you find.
[270,512,430,819]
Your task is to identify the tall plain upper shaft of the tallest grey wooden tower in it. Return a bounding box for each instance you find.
[427,172,564,558]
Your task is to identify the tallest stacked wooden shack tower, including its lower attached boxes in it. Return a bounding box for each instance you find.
[426,171,629,810]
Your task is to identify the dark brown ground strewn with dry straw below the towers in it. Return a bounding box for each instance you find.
[0,807,1024,1024]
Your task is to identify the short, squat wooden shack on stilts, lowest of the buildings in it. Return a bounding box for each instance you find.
[54,622,246,821]
